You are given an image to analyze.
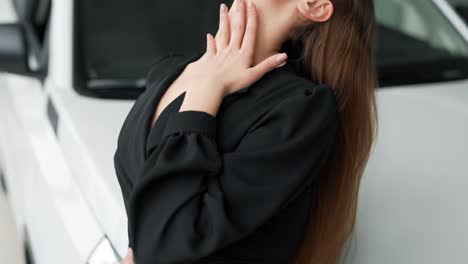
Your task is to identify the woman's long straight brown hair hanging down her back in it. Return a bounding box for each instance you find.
[290,0,378,264]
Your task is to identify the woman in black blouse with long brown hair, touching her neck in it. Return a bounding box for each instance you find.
[114,0,377,264]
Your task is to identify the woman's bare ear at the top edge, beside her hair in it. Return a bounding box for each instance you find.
[297,0,333,22]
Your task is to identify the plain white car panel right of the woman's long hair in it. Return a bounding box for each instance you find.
[346,81,468,264]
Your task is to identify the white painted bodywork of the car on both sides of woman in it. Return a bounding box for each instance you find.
[0,0,468,264]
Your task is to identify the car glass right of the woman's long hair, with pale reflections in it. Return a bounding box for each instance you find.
[376,0,468,87]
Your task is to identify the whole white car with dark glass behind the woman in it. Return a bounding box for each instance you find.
[0,0,468,264]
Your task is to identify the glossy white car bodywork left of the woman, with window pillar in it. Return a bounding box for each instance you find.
[0,1,126,264]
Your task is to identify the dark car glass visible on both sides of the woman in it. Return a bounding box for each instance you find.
[74,0,468,98]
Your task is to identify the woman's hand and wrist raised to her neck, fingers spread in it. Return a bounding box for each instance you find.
[173,0,287,116]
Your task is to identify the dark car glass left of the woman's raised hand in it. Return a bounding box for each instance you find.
[76,0,226,98]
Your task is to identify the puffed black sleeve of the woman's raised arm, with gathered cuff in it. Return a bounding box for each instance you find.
[130,86,339,264]
